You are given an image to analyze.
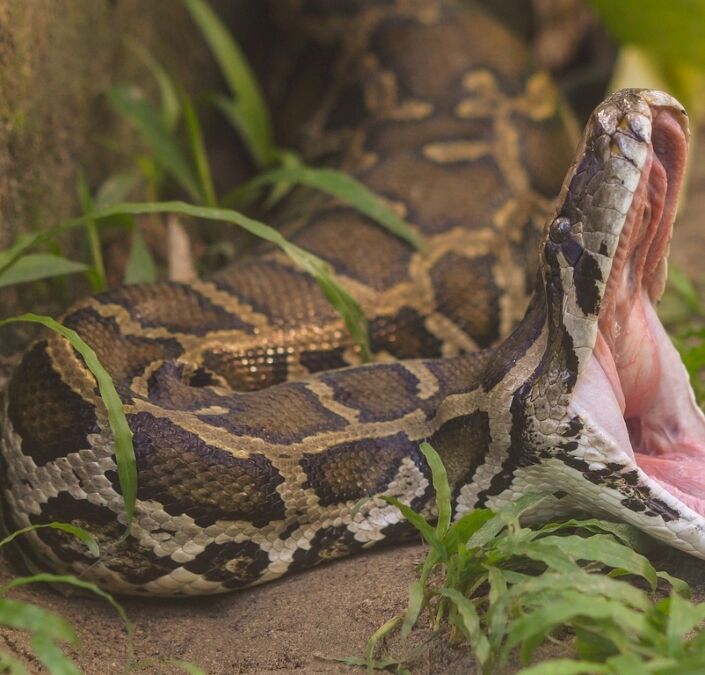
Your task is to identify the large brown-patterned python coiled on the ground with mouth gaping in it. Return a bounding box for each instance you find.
[0,0,705,596]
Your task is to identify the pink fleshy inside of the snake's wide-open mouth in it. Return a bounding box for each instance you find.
[574,107,705,515]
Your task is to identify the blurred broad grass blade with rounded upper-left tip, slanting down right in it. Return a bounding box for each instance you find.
[108,84,205,202]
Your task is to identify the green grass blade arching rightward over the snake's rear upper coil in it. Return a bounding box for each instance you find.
[250,166,423,249]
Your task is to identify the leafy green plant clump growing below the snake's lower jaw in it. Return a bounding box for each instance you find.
[342,443,705,675]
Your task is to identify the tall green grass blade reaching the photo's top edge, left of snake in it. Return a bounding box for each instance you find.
[182,0,277,167]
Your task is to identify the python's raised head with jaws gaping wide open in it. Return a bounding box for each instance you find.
[506,90,705,557]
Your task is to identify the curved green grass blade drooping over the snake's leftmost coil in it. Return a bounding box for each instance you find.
[0,313,137,523]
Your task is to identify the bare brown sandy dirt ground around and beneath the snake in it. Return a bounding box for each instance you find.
[0,124,705,675]
